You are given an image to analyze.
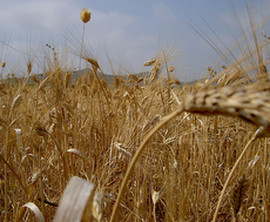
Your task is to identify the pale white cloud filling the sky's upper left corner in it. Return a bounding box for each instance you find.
[0,0,78,33]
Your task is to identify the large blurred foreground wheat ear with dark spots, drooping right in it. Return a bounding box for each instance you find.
[182,83,270,137]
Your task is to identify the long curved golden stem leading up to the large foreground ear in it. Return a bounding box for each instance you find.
[110,106,183,222]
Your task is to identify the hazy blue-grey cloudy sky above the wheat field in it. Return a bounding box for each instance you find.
[0,0,270,80]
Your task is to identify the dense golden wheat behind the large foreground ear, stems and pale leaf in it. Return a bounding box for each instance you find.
[0,59,270,221]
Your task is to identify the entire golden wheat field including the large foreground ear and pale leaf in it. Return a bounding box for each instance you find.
[0,6,270,221]
